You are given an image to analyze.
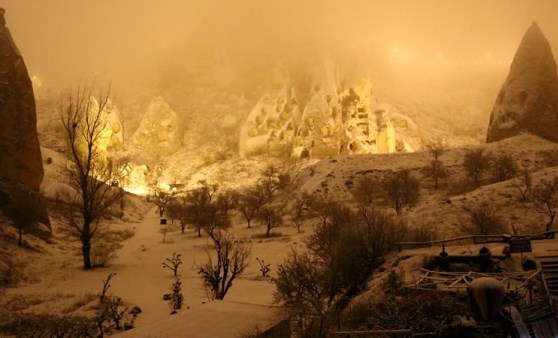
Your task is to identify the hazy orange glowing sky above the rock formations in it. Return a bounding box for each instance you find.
[0,0,558,87]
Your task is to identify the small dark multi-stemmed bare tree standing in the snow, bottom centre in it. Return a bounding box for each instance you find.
[196,230,252,299]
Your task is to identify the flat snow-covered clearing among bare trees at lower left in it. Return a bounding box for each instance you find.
[5,197,301,337]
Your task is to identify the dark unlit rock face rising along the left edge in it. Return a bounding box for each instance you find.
[0,8,44,191]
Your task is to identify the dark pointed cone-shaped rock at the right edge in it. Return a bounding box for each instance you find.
[486,23,558,142]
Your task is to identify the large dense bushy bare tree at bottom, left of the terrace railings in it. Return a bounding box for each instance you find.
[274,206,406,337]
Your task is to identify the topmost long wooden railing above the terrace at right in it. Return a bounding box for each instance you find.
[395,230,558,252]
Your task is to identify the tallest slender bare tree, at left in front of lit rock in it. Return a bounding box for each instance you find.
[59,87,119,270]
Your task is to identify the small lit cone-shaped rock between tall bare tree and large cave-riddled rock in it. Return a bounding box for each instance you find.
[133,97,182,156]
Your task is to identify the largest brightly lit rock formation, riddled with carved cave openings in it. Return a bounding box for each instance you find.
[239,62,417,158]
